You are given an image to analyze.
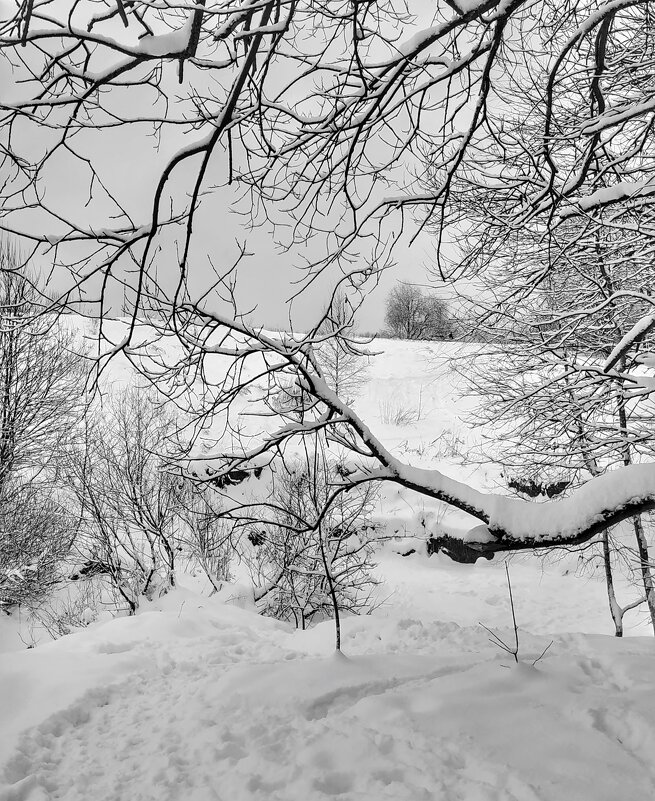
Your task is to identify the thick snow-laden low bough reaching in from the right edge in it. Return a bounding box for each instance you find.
[172,307,655,562]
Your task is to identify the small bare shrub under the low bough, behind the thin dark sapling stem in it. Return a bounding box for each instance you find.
[249,437,376,650]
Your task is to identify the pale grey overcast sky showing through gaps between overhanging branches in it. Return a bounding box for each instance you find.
[0,0,448,331]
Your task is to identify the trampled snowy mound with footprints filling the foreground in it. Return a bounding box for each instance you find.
[0,556,655,801]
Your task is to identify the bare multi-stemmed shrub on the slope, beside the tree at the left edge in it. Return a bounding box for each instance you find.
[69,387,183,612]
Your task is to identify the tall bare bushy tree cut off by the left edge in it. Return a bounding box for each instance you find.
[0,241,85,607]
